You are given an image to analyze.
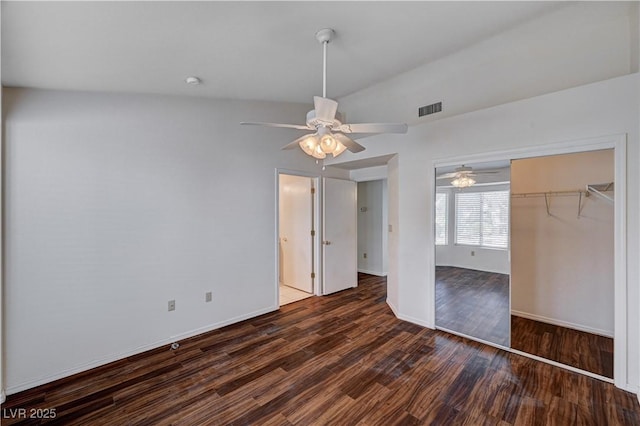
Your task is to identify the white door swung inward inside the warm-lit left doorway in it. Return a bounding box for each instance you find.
[279,175,313,293]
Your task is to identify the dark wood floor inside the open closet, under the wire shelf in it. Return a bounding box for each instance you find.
[511,316,613,379]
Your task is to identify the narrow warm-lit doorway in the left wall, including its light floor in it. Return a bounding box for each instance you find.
[278,174,317,306]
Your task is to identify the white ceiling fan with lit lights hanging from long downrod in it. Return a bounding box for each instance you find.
[240,28,407,159]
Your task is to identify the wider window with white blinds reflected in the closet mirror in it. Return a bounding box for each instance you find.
[456,191,509,249]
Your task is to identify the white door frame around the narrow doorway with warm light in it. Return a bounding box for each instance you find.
[274,168,322,307]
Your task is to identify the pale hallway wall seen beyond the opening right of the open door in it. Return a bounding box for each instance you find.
[358,180,387,276]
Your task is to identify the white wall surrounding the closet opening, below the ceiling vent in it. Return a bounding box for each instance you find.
[330,74,640,391]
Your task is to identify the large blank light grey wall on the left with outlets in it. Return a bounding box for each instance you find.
[4,89,347,393]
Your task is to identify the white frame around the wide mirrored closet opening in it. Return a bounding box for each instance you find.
[427,133,637,392]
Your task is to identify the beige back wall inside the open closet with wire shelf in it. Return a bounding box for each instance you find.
[511,150,614,337]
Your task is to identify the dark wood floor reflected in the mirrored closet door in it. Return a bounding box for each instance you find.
[436,266,511,347]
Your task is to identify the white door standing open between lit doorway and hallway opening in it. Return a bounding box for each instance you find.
[322,178,358,294]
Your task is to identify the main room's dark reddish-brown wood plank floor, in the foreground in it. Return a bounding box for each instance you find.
[2,275,640,426]
